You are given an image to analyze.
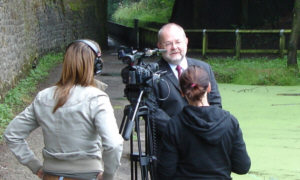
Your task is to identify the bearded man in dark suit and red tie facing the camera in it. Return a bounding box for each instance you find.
[146,23,222,135]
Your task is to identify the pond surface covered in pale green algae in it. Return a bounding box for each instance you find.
[219,84,300,180]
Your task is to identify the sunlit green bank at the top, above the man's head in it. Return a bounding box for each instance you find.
[112,0,174,26]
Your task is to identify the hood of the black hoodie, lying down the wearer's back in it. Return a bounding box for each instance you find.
[182,105,231,144]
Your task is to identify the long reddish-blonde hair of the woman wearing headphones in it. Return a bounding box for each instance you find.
[53,40,100,113]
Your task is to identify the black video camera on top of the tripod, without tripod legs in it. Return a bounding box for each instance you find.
[118,46,166,102]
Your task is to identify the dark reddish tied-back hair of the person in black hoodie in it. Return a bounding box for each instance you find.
[179,66,209,101]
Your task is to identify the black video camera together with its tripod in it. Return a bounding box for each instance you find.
[118,47,166,180]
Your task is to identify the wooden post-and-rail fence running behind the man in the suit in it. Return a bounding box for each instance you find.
[106,20,291,58]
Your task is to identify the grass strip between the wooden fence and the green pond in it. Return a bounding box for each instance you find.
[207,57,300,86]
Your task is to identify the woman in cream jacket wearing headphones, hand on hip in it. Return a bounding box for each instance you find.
[4,39,123,180]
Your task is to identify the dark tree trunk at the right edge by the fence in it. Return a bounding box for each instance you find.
[287,0,300,70]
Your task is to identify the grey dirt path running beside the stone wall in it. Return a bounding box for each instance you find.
[0,40,130,180]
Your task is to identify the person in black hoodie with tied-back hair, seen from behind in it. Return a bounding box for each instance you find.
[157,66,251,180]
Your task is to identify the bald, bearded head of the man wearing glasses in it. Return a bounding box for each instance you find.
[157,26,188,64]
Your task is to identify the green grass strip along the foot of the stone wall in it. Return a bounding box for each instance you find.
[0,53,63,142]
